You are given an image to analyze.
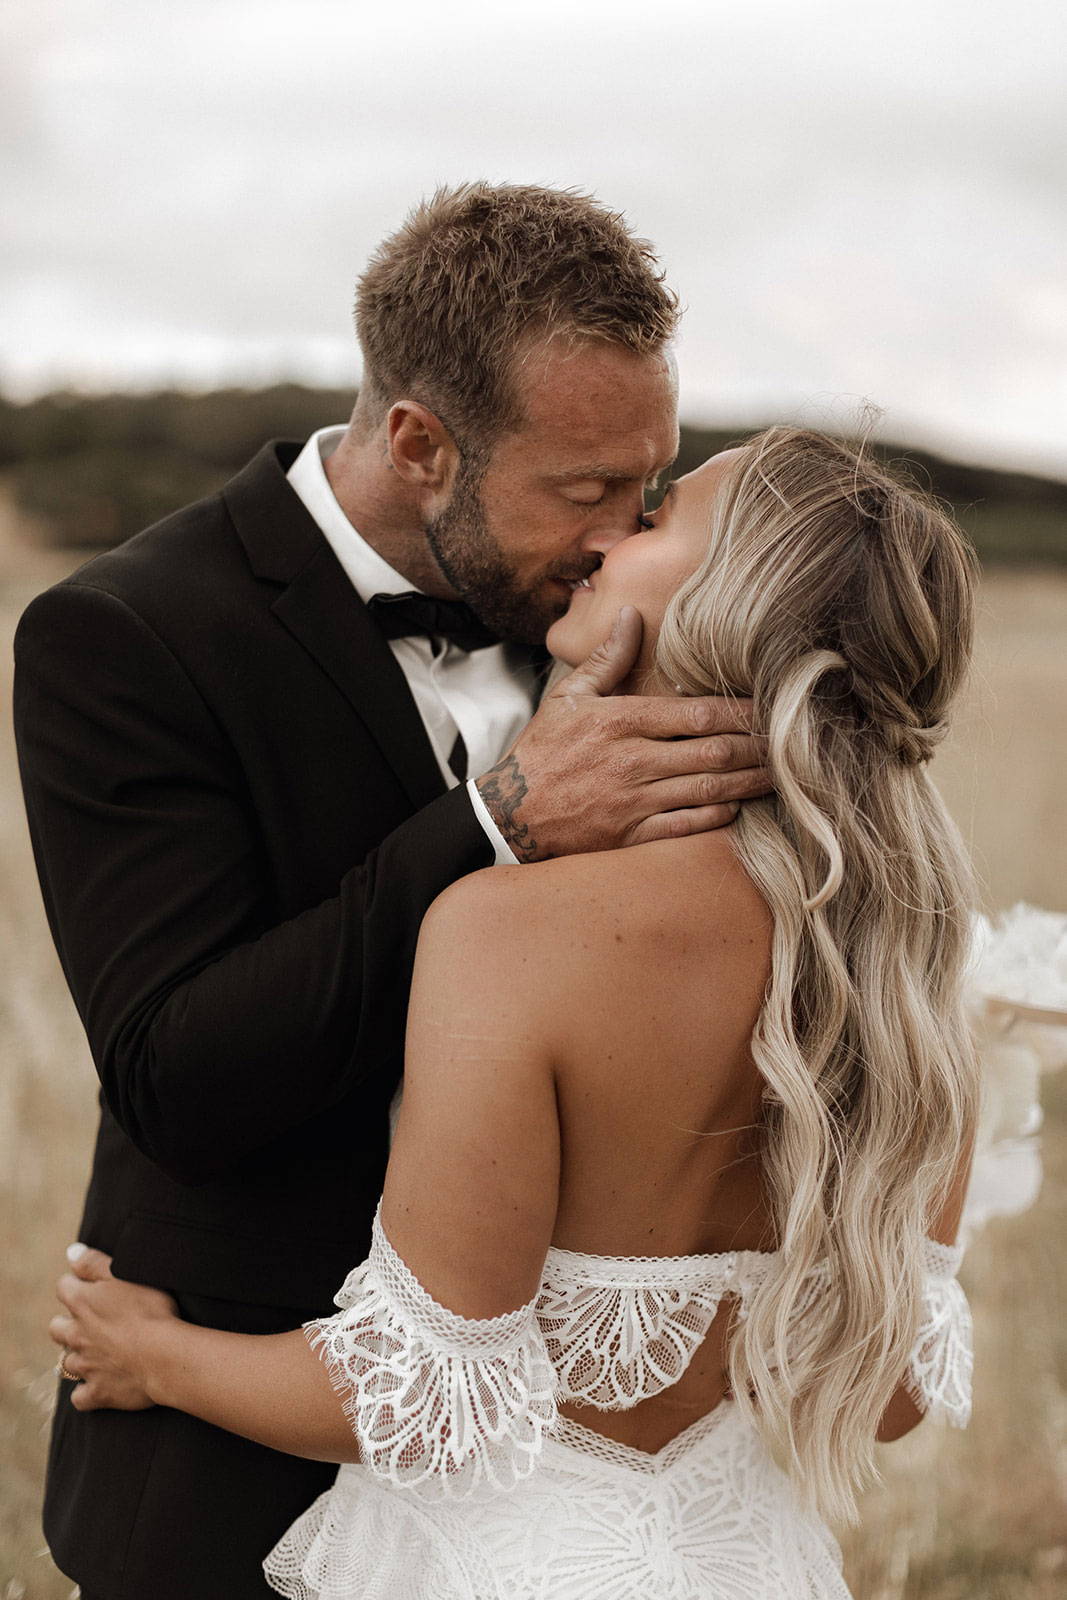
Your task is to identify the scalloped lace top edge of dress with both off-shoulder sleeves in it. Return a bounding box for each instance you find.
[306,1208,973,1496]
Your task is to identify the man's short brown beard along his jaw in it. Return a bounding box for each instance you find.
[426,459,574,645]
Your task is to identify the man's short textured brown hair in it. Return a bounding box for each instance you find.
[355,182,678,454]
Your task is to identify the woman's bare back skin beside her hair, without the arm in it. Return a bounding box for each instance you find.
[508,834,774,1451]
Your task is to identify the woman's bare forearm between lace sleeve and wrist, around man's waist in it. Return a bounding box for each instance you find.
[138,1318,360,1461]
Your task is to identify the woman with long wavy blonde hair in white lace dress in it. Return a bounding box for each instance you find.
[51,429,979,1600]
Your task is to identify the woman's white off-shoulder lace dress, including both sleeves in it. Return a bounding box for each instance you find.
[264,1218,971,1600]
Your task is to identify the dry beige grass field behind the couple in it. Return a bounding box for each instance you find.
[0,489,1067,1600]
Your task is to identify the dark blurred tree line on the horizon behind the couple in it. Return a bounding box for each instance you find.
[0,384,1067,565]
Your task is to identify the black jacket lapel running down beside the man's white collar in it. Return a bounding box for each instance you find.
[222,443,445,810]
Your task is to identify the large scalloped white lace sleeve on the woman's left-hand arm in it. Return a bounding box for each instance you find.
[304,1214,555,1496]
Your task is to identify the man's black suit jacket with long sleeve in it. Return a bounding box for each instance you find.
[16,445,521,1600]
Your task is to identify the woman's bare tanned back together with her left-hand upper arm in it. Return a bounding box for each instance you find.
[382,834,774,1450]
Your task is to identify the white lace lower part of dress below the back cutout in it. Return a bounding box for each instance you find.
[267,1405,848,1600]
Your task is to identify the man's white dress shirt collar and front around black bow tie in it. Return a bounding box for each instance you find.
[288,426,537,864]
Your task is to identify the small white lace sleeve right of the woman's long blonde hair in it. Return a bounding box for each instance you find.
[905,1238,974,1427]
